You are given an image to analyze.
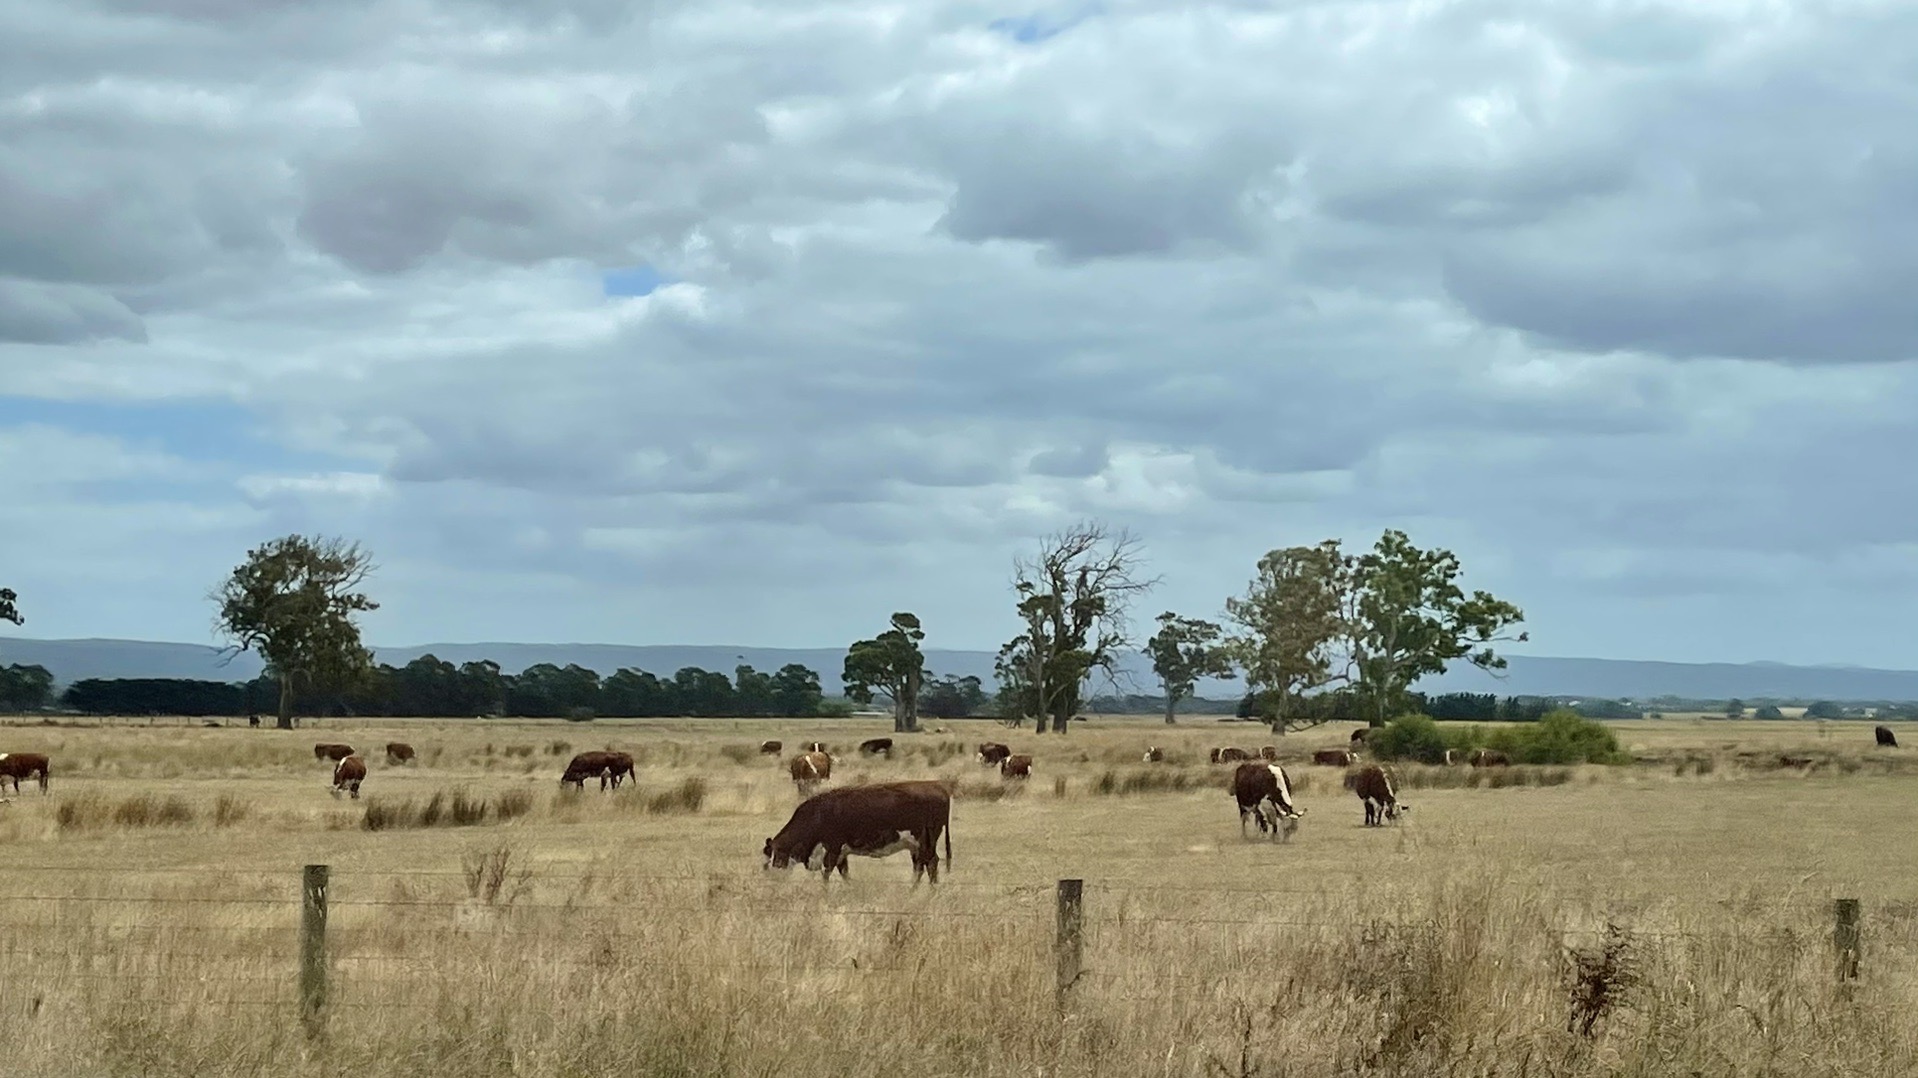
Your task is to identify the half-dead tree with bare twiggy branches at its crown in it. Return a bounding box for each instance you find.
[997,522,1158,733]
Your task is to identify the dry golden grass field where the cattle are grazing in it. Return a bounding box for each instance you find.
[0,717,1918,1078]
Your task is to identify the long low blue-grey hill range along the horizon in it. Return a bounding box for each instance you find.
[0,637,1918,700]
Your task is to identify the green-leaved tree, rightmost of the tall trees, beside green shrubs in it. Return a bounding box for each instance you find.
[1346,529,1531,725]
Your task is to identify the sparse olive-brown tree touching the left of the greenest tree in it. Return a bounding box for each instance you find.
[1226,539,1354,733]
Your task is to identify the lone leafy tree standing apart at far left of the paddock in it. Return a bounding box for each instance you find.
[211,535,380,729]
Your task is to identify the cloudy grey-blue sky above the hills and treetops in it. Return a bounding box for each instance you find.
[0,0,1918,666]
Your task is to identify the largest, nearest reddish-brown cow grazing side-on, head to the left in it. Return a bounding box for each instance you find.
[765,781,953,886]
